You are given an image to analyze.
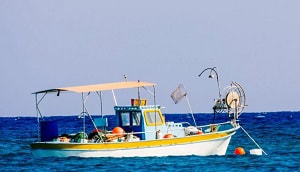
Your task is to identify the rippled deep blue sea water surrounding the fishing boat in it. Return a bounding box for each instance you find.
[0,112,300,172]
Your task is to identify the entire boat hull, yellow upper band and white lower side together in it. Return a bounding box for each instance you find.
[30,128,238,157]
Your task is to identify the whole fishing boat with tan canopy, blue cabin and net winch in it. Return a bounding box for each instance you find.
[30,71,245,157]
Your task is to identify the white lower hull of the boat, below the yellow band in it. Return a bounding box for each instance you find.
[32,132,235,157]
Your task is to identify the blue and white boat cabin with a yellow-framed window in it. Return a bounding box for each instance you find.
[114,99,185,140]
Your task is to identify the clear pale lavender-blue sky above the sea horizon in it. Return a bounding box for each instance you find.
[0,0,300,116]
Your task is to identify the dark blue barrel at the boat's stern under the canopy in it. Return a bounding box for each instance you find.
[41,121,58,142]
